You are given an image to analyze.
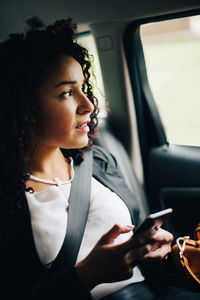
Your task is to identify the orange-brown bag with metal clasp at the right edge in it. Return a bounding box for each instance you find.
[172,223,200,289]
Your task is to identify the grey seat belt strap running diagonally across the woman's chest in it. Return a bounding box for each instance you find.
[50,151,93,273]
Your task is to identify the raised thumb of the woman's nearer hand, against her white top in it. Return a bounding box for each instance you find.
[99,224,135,245]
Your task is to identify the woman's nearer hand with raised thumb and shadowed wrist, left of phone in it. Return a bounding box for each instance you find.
[75,225,134,290]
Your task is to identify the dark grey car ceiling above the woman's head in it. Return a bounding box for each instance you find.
[0,0,200,40]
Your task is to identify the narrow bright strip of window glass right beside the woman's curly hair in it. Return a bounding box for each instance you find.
[78,32,106,117]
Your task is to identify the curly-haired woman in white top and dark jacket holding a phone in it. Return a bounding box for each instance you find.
[0,20,198,299]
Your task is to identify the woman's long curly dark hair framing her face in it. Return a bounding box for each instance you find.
[0,19,98,211]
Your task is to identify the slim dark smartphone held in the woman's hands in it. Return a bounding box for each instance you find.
[133,208,173,237]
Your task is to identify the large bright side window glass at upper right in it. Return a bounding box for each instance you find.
[140,16,200,146]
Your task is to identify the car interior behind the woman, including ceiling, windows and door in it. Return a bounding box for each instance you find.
[0,0,200,237]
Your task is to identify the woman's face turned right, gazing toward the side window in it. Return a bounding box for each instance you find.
[37,56,94,149]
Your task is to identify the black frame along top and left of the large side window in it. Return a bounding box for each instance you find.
[124,9,200,171]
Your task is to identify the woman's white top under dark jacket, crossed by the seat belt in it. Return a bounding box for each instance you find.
[26,166,144,299]
